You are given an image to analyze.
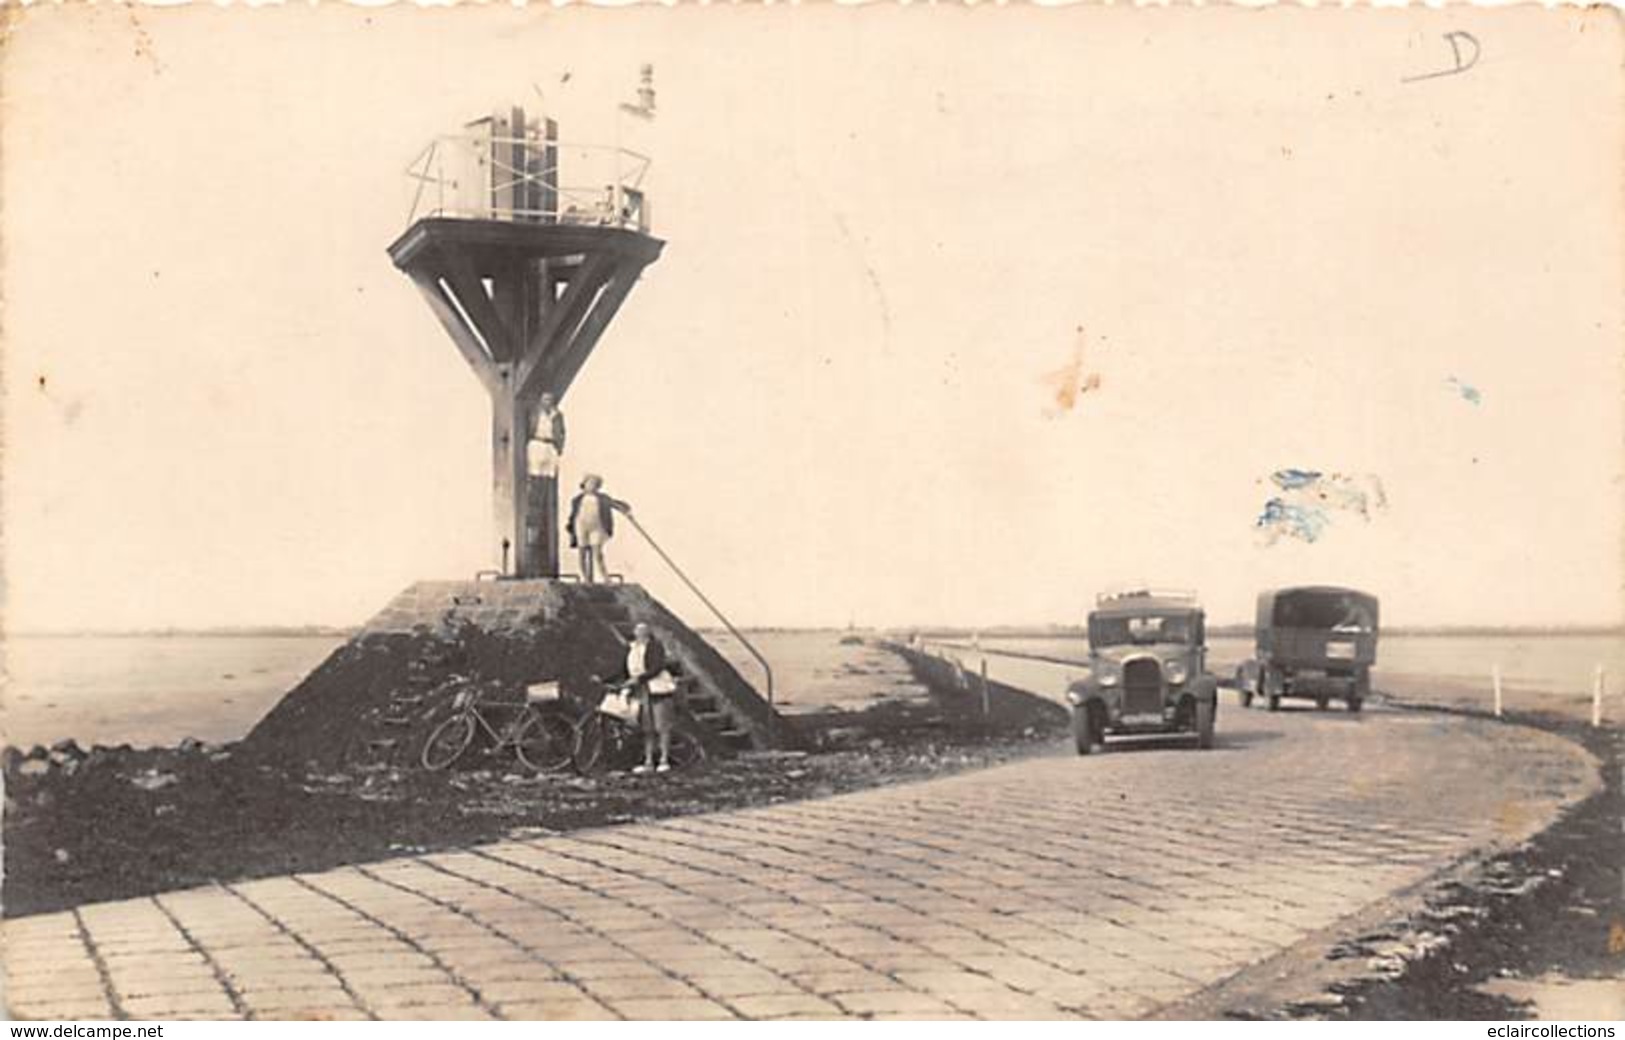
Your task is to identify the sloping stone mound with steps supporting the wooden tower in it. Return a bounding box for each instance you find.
[242,580,790,769]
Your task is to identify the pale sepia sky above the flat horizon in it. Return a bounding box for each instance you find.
[0,5,1625,631]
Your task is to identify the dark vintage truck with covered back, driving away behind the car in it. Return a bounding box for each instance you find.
[1240,585,1376,712]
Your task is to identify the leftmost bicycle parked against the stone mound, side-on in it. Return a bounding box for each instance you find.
[423,678,577,772]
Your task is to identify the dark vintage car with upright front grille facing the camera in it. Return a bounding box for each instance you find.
[1066,590,1219,754]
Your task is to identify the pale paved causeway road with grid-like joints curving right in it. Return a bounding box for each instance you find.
[3,702,1594,1019]
